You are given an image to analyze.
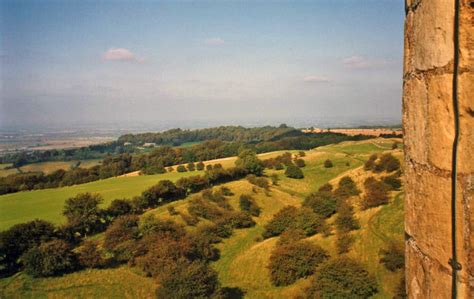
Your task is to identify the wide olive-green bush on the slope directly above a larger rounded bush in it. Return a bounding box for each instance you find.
[263,206,325,238]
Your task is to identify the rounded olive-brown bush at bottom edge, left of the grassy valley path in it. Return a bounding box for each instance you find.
[156,261,219,299]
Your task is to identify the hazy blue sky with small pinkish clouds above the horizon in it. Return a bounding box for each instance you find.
[0,0,404,127]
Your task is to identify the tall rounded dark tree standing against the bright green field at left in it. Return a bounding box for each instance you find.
[63,193,103,235]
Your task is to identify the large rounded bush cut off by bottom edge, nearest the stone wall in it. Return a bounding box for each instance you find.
[308,256,377,299]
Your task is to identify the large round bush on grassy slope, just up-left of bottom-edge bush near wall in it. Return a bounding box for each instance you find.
[268,241,329,286]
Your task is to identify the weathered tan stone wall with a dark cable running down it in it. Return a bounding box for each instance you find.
[403,0,474,298]
